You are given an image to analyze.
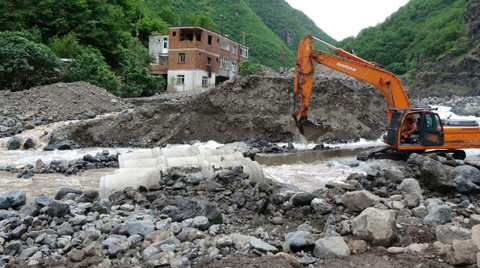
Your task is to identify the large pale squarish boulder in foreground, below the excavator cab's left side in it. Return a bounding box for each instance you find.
[352,208,396,247]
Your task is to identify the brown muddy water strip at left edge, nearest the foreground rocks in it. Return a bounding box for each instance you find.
[0,168,115,202]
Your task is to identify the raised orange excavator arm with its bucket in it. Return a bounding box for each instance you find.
[293,35,410,140]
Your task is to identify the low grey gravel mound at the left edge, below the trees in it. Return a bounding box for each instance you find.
[0,82,125,123]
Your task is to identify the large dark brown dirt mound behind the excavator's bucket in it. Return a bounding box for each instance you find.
[52,76,387,146]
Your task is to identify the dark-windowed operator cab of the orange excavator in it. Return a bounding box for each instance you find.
[386,109,444,149]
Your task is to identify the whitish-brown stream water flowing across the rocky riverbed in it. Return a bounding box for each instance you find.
[0,107,480,201]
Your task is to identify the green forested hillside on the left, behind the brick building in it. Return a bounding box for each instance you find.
[0,0,334,93]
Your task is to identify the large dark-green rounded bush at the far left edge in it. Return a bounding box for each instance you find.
[0,31,59,91]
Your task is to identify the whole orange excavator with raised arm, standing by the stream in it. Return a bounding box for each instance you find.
[292,35,480,159]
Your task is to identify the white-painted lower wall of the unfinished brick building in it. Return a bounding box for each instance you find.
[167,70,216,92]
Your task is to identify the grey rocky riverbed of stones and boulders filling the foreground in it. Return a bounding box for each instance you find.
[0,151,480,267]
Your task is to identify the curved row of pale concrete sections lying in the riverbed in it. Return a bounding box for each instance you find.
[100,145,263,198]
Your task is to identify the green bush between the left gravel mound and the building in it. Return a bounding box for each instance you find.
[63,49,120,95]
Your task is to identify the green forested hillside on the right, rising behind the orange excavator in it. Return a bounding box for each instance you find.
[339,0,480,94]
